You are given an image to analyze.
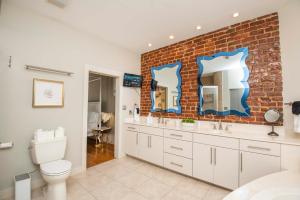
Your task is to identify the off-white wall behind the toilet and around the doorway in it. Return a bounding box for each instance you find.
[0,1,140,195]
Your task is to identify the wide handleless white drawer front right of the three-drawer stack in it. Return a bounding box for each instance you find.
[194,133,239,149]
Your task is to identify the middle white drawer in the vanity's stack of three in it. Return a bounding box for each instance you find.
[164,138,193,158]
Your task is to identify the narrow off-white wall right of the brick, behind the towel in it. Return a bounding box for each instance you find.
[279,0,300,130]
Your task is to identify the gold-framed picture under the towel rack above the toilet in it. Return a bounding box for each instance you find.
[32,79,64,108]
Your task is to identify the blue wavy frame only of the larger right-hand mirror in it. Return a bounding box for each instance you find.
[197,47,251,117]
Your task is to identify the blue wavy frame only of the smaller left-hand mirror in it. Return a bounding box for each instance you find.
[150,61,182,114]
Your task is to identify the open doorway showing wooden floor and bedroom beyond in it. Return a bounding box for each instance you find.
[86,72,116,167]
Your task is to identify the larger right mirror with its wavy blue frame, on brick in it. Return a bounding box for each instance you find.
[197,48,250,116]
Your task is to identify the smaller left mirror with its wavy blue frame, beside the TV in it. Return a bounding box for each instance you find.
[151,62,182,113]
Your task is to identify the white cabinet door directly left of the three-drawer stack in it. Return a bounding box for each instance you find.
[148,135,164,166]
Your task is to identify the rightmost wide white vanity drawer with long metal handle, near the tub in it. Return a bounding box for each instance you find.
[240,140,280,156]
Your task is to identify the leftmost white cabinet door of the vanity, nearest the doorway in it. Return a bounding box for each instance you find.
[125,130,138,157]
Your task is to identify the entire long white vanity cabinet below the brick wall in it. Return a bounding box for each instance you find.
[124,123,300,189]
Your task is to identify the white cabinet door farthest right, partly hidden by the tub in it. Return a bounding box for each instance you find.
[240,151,280,186]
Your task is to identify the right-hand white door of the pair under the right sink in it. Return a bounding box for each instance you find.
[214,147,239,189]
